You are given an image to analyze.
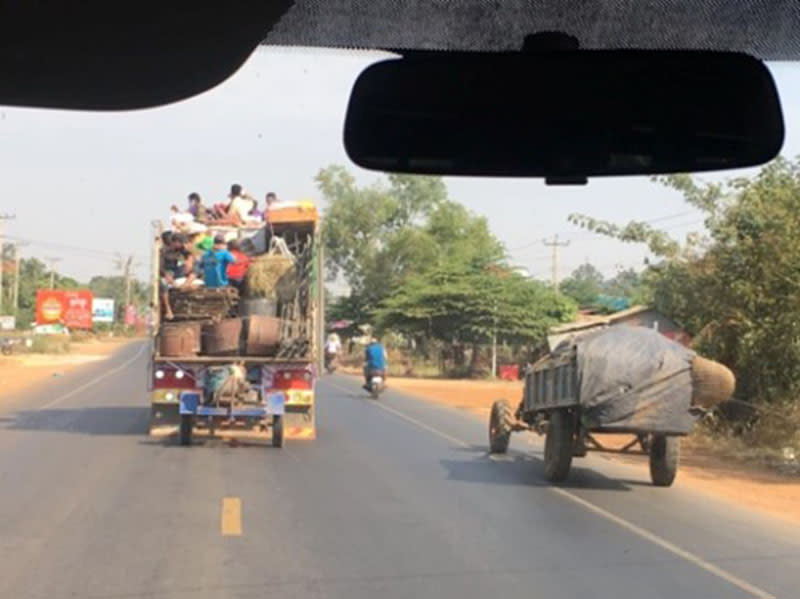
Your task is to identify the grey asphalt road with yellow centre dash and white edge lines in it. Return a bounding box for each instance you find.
[0,344,800,599]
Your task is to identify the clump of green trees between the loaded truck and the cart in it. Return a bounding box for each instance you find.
[316,166,576,354]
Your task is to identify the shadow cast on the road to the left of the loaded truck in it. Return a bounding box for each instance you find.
[0,406,150,435]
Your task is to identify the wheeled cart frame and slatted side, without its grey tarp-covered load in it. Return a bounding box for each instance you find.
[489,347,685,487]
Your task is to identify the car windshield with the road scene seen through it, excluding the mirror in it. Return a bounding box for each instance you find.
[0,46,800,598]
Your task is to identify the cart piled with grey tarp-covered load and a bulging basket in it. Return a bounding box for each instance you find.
[489,326,735,486]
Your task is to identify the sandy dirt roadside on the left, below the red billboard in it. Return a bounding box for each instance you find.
[0,338,130,402]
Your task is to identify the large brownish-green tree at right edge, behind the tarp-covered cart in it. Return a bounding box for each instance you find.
[570,158,800,401]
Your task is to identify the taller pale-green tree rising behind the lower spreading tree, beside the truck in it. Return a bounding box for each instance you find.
[316,166,496,314]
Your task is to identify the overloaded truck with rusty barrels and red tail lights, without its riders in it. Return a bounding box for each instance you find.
[148,206,323,447]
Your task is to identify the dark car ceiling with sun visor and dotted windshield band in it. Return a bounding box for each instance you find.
[0,0,800,110]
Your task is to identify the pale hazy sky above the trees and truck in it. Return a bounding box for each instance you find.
[0,47,800,282]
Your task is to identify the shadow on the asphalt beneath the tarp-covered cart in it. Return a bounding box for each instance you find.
[440,448,649,491]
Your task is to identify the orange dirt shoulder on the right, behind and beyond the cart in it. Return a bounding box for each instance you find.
[382,378,800,523]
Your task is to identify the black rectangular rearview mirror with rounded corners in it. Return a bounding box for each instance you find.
[344,50,784,182]
